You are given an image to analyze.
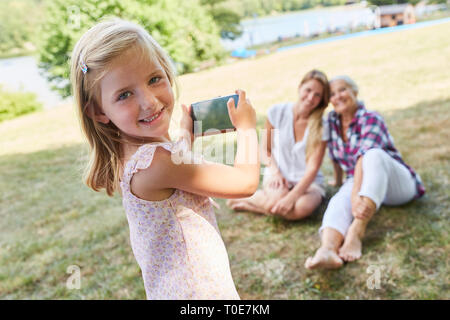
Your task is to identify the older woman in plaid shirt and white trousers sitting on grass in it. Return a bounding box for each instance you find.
[305,76,425,269]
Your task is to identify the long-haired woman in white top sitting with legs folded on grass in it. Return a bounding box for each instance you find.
[227,70,330,220]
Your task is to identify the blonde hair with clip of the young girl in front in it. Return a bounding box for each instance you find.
[70,18,176,196]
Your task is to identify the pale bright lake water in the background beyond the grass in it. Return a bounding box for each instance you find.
[0,5,444,108]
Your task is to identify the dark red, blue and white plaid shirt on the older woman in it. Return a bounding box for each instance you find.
[327,103,425,197]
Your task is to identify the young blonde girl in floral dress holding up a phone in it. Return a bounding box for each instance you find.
[71,19,259,299]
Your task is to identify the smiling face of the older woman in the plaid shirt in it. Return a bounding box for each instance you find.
[330,80,358,114]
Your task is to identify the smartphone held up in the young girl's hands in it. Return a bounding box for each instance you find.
[191,94,239,137]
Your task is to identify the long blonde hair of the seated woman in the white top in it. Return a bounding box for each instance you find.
[299,70,330,160]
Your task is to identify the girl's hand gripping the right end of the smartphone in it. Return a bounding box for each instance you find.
[227,90,256,130]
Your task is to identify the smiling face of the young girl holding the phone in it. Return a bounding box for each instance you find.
[97,49,174,140]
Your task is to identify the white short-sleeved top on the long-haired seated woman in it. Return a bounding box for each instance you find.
[267,102,329,187]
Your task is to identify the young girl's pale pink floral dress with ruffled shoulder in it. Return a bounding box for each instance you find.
[121,140,239,300]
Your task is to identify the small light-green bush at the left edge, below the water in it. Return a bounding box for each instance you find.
[0,87,42,122]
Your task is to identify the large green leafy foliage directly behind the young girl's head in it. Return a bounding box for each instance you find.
[39,0,224,96]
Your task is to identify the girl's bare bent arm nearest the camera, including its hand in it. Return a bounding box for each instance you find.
[132,91,259,200]
